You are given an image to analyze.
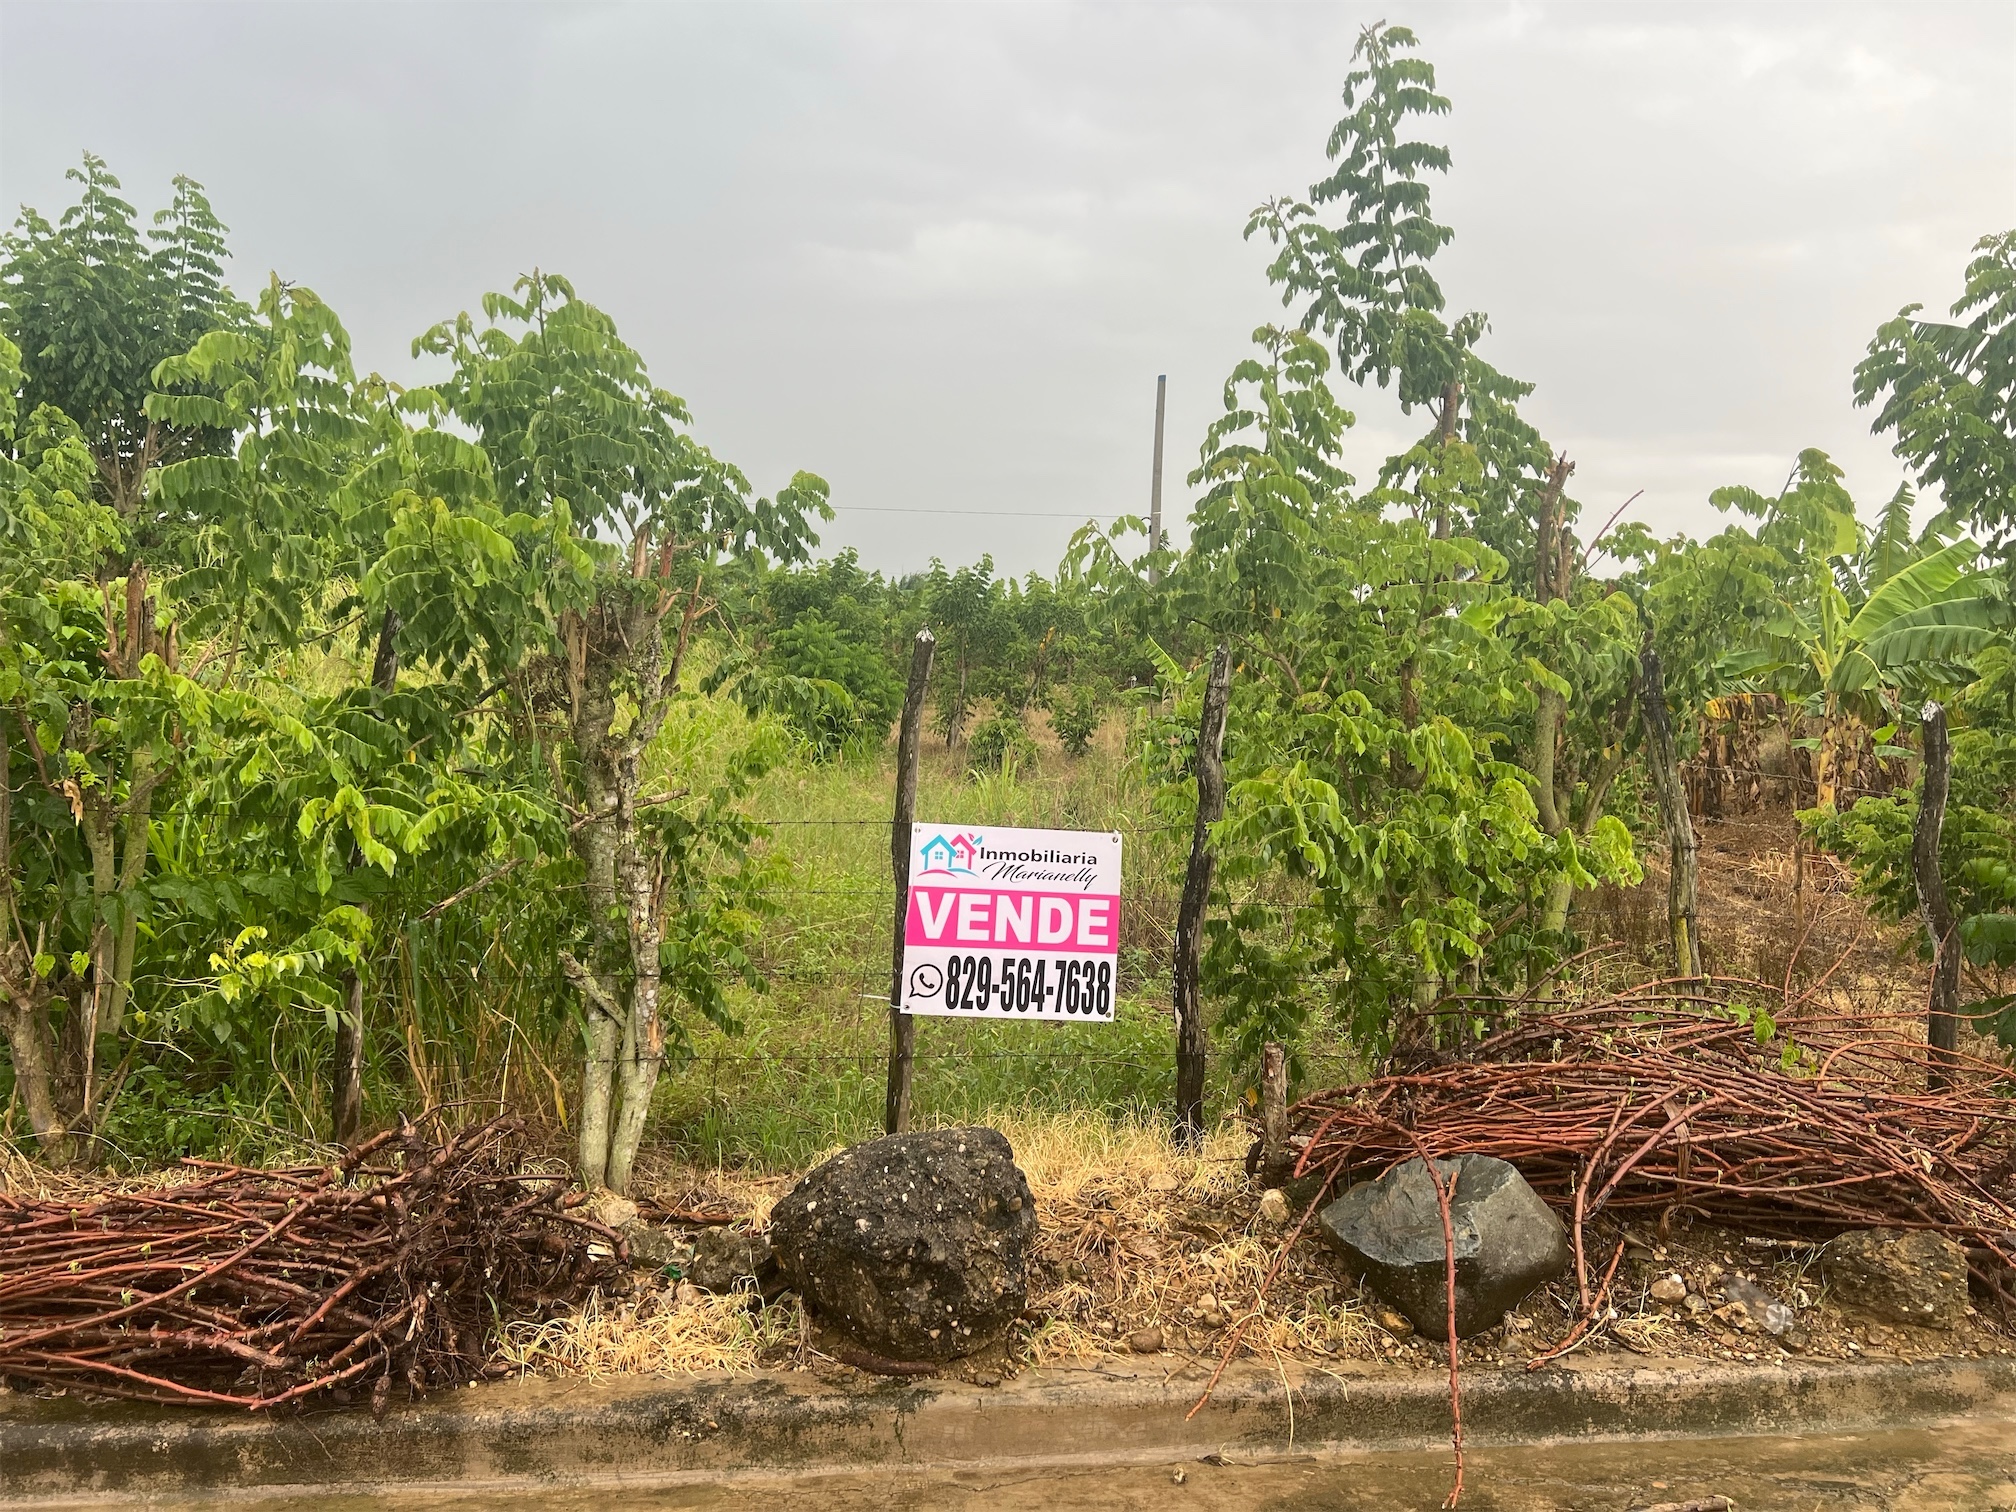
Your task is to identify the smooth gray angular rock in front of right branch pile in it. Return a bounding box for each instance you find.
[1316,1155,1568,1339]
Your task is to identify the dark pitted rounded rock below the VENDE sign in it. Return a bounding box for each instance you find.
[770,1129,1036,1361]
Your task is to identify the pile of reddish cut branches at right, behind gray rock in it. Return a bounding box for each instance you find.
[1290,980,2016,1314]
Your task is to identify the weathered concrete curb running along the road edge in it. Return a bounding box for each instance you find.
[0,1359,2016,1504]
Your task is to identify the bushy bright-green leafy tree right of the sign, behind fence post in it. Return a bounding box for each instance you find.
[1077,314,1635,1056]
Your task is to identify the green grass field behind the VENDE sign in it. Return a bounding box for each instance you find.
[649,728,1226,1169]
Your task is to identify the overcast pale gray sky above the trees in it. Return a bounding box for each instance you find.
[0,0,2016,573]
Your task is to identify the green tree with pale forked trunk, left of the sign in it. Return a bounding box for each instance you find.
[415,272,831,1191]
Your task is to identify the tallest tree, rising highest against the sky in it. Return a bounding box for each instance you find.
[1246,24,1635,959]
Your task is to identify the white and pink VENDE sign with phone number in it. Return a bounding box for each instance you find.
[897,825,1121,1024]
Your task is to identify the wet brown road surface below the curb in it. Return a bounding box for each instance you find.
[130,1421,2016,1512]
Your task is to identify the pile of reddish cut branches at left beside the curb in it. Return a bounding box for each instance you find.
[0,1119,621,1409]
